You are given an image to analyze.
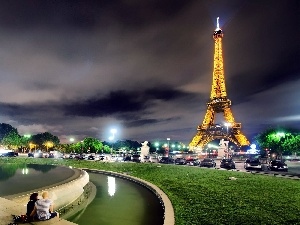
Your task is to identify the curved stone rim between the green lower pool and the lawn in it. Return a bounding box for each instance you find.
[82,168,175,225]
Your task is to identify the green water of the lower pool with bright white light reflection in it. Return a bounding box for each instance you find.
[67,172,163,225]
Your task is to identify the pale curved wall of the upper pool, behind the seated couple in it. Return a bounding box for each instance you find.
[8,166,89,209]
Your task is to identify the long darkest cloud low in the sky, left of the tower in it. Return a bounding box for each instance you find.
[64,86,195,117]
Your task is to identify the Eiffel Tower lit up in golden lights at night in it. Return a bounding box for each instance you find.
[189,17,250,150]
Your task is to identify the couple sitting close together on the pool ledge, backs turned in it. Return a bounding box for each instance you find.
[26,191,59,221]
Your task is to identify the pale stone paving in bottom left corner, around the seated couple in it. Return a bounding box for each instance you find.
[0,198,76,225]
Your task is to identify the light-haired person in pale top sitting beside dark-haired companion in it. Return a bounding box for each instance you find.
[30,191,59,220]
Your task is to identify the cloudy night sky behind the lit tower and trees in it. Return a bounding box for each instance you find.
[0,0,300,143]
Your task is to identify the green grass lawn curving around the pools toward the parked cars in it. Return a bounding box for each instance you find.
[0,158,300,225]
